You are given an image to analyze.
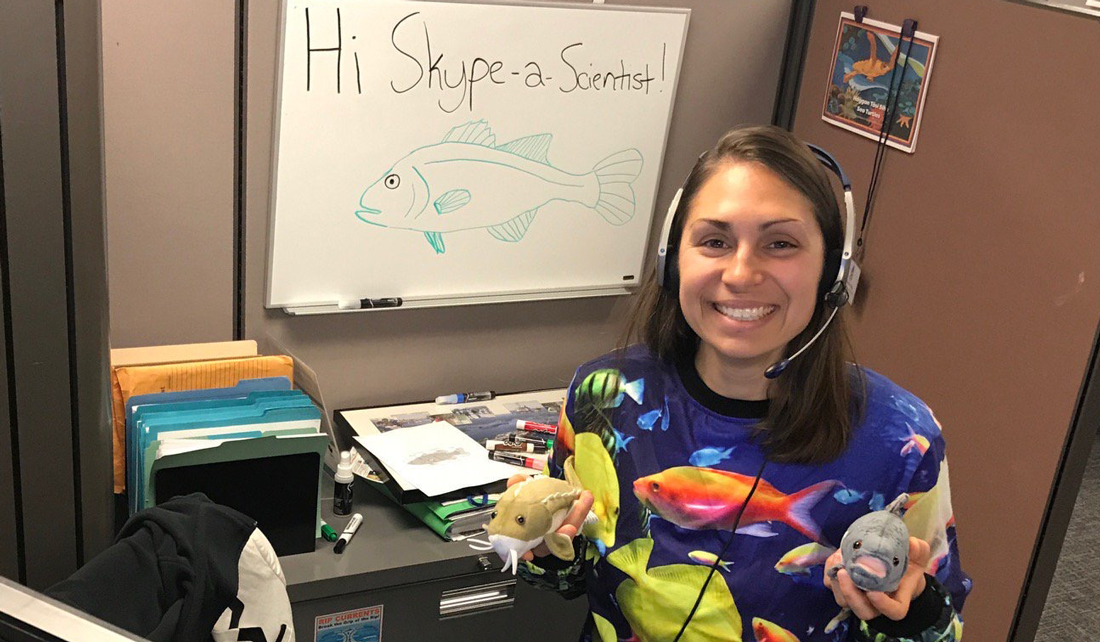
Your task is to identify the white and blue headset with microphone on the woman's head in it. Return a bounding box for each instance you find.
[657,144,859,379]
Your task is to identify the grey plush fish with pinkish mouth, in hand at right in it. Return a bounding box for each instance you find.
[829,492,909,593]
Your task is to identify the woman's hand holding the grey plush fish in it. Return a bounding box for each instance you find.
[825,538,932,621]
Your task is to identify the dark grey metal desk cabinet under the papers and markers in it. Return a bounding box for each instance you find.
[279,476,587,642]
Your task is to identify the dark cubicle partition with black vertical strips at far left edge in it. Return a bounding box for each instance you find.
[0,2,113,588]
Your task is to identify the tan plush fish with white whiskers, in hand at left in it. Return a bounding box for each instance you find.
[470,457,596,575]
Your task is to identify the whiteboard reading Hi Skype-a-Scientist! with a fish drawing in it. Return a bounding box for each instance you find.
[266,0,689,313]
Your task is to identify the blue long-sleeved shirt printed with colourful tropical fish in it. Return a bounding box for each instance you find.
[520,346,971,642]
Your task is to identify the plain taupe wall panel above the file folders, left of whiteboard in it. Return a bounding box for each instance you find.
[102,0,235,347]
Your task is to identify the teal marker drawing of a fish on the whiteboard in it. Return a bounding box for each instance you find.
[355,120,642,254]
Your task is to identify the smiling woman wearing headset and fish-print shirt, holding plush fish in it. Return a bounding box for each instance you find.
[521,128,970,642]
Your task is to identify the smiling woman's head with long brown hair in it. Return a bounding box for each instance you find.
[623,128,849,463]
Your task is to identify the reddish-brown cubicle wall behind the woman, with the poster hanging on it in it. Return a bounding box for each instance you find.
[794,0,1100,642]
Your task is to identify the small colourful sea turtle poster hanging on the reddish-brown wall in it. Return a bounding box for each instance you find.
[822,13,939,154]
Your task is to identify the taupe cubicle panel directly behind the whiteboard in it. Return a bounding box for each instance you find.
[244,0,792,408]
